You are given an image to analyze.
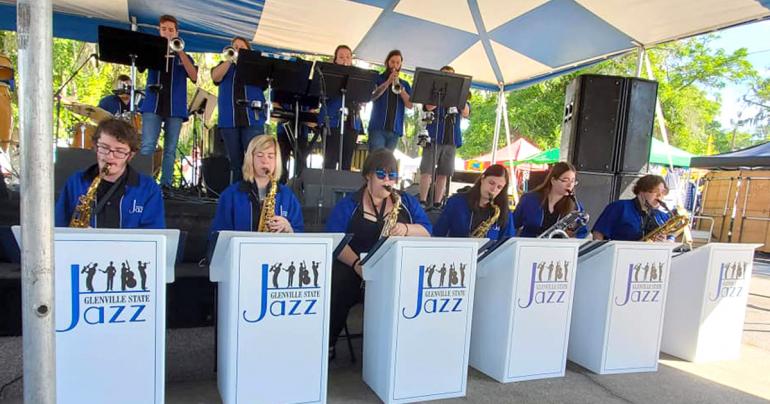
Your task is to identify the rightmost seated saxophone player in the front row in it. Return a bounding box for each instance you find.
[592,174,670,241]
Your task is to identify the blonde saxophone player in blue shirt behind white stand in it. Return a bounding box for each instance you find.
[210,136,304,234]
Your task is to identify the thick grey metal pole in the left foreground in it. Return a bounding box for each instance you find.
[16,0,56,404]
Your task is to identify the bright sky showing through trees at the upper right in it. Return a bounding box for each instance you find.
[711,21,770,129]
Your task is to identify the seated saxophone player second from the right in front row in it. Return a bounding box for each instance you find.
[513,161,588,238]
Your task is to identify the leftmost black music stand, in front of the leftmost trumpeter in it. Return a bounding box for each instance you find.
[98,25,168,115]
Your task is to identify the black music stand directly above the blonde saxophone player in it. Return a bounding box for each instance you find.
[235,49,311,130]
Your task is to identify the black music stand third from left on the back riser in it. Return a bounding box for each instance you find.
[308,62,378,170]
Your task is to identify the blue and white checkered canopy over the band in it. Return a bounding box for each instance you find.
[0,0,770,89]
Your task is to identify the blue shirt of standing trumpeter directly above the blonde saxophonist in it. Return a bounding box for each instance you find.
[214,63,267,128]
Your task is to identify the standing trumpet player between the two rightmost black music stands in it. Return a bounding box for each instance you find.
[369,49,412,152]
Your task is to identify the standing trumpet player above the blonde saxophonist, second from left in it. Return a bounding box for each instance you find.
[211,37,267,183]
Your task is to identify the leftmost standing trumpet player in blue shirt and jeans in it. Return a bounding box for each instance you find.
[139,15,198,187]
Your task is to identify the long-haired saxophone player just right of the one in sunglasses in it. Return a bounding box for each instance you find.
[433,164,514,240]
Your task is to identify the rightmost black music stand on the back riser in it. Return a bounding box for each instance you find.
[410,67,472,206]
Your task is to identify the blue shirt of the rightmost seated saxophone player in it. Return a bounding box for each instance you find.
[592,198,669,241]
